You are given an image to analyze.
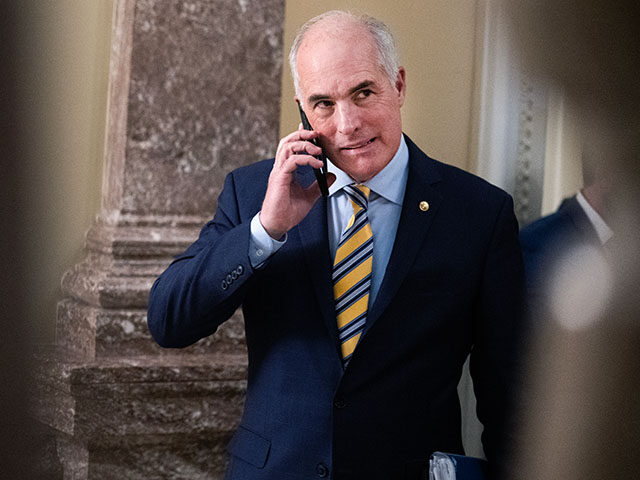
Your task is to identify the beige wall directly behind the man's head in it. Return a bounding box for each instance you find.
[280,0,476,168]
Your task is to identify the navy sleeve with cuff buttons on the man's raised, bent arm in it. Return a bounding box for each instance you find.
[147,173,256,347]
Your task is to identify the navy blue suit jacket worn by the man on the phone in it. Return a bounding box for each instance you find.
[148,138,523,480]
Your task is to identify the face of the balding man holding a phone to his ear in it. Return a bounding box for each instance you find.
[298,24,405,182]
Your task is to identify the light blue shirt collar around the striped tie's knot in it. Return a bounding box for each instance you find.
[327,135,409,205]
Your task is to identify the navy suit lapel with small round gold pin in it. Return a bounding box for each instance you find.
[365,137,442,333]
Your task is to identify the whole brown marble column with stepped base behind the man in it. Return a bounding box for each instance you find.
[34,0,284,480]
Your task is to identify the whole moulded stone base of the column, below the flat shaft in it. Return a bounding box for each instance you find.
[33,212,247,480]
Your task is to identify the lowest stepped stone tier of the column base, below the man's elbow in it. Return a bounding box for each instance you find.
[34,347,246,480]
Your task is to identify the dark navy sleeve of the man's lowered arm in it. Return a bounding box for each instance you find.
[470,196,524,465]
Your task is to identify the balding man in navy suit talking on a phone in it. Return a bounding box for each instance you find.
[148,12,523,480]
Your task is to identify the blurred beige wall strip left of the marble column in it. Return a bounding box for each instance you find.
[21,0,113,342]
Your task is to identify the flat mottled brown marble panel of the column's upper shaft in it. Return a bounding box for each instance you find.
[119,0,283,215]
